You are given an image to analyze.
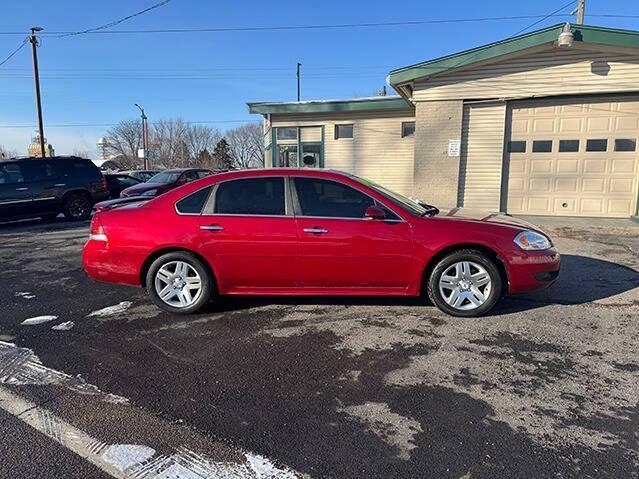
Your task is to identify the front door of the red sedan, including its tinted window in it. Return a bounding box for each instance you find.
[293,177,413,294]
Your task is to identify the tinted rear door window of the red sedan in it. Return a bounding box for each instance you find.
[215,178,286,216]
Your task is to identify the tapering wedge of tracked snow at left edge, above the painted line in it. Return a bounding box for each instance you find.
[0,341,128,404]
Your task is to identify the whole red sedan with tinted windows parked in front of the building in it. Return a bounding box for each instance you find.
[83,169,560,316]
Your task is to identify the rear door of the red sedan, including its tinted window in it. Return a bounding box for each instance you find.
[199,177,299,294]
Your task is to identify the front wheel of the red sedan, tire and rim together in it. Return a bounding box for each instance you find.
[428,249,503,317]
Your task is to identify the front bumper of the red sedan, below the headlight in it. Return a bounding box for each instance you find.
[508,248,561,294]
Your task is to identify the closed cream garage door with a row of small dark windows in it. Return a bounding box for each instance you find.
[506,98,639,217]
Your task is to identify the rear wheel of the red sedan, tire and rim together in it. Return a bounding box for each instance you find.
[146,251,215,314]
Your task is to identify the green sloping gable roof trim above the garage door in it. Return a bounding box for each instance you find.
[389,23,639,87]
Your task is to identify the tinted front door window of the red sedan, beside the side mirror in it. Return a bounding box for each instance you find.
[295,178,375,218]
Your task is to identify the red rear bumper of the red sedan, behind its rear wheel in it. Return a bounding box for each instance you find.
[82,239,144,286]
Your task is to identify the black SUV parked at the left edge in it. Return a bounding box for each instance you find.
[0,156,109,225]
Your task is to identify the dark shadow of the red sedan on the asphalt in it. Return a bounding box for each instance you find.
[206,255,639,316]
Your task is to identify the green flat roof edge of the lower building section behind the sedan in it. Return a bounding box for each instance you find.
[247,96,412,114]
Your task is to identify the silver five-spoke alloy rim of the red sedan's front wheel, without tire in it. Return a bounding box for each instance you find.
[439,261,492,311]
